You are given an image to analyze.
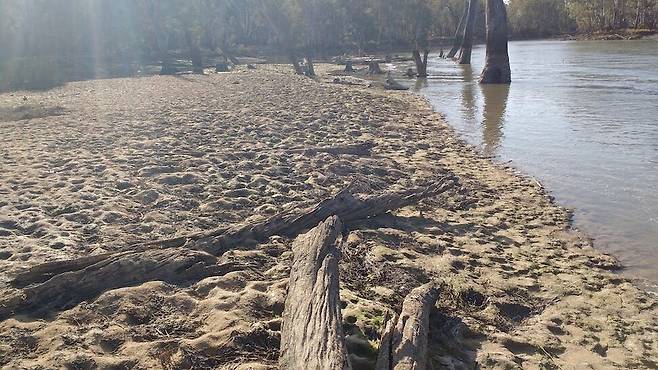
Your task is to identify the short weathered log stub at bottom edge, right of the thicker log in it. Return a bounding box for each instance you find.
[376,282,439,370]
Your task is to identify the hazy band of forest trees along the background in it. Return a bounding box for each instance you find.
[0,0,658,89]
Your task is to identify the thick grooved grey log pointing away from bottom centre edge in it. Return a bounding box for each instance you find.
[279,216,350,370]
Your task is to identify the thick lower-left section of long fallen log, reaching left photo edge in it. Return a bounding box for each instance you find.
[0,248,249,320]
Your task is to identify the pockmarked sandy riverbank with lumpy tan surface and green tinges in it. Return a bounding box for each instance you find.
[0,66,658,369]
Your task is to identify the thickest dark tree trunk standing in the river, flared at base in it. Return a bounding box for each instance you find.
[480,0,512,84]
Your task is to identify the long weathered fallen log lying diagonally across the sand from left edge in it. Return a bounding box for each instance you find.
[5,176,457,317]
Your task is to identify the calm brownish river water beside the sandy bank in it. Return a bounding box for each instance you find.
[398,40,658,291]
